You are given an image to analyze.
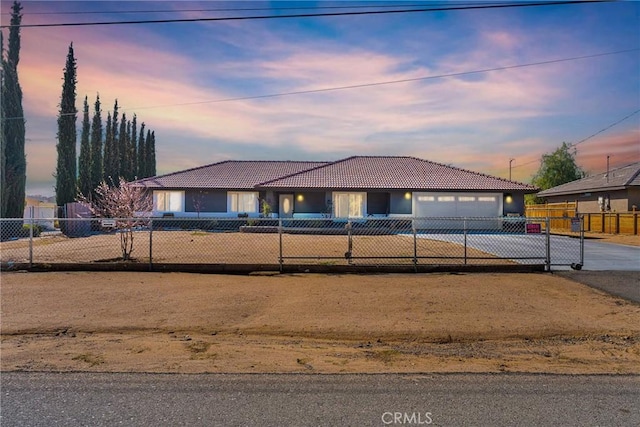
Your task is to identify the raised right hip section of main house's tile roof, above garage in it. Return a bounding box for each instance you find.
[260,156,536,192]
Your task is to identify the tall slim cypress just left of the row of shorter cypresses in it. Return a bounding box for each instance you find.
[56,43,77,206]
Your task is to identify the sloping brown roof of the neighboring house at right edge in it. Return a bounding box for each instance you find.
[538,162,640,197]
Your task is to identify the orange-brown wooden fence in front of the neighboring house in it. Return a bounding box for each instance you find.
[525,202,640,235]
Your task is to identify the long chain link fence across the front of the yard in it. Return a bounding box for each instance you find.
[0,217,583,270]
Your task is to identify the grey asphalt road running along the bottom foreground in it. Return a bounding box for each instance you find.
[0,373,640,427]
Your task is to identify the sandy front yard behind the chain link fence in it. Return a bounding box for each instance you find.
[0,230,511,265]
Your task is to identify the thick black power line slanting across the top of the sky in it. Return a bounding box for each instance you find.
[0,0,615,28]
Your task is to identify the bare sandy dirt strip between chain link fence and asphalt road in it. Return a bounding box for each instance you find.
[0,272,640,374]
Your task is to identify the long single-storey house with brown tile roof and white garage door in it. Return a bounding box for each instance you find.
[135,156,537,224]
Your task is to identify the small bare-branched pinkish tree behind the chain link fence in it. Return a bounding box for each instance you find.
[78,178,153,261]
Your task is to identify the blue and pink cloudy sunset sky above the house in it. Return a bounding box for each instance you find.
[0,0,640,196]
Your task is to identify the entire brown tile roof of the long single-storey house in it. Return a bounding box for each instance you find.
[135,156,537,192]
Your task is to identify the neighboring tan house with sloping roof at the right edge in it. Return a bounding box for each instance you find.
[538,162,640,213]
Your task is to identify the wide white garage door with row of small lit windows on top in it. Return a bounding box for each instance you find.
[413,193,502,229]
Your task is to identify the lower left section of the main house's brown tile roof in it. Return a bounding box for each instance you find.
[135,160,326,190]
